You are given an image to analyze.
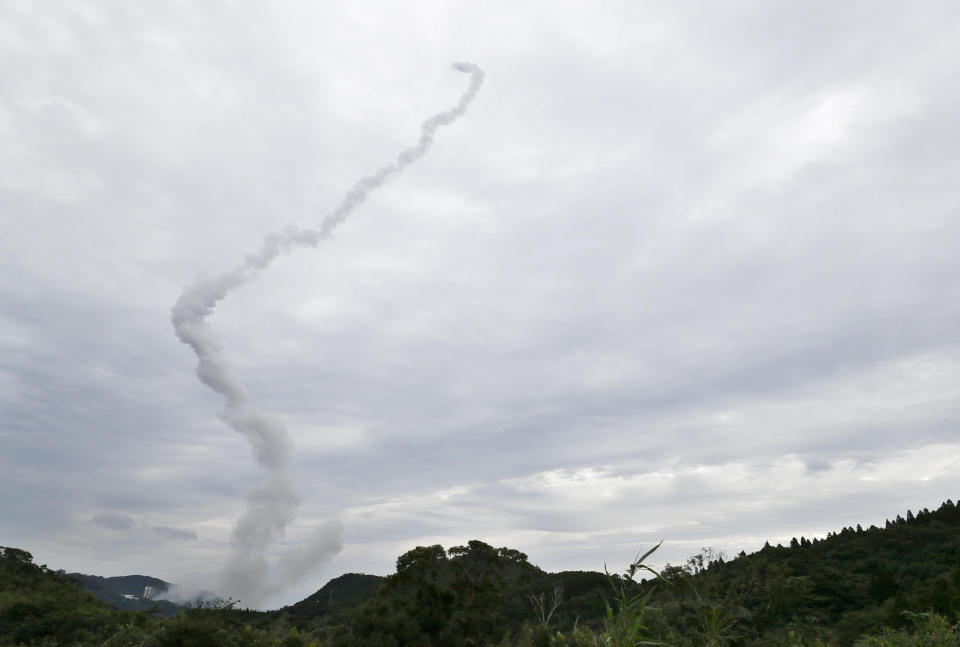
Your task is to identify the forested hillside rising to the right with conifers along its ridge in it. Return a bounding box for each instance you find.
[648,500,960,645]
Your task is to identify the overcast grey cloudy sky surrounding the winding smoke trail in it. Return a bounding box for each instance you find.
[0,0,960,607]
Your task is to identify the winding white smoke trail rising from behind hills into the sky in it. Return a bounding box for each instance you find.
[171,63,484,606]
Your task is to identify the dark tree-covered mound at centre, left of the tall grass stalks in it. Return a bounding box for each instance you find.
[275,540,624,644]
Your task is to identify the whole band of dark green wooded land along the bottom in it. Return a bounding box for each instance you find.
[0,501,960,647]
